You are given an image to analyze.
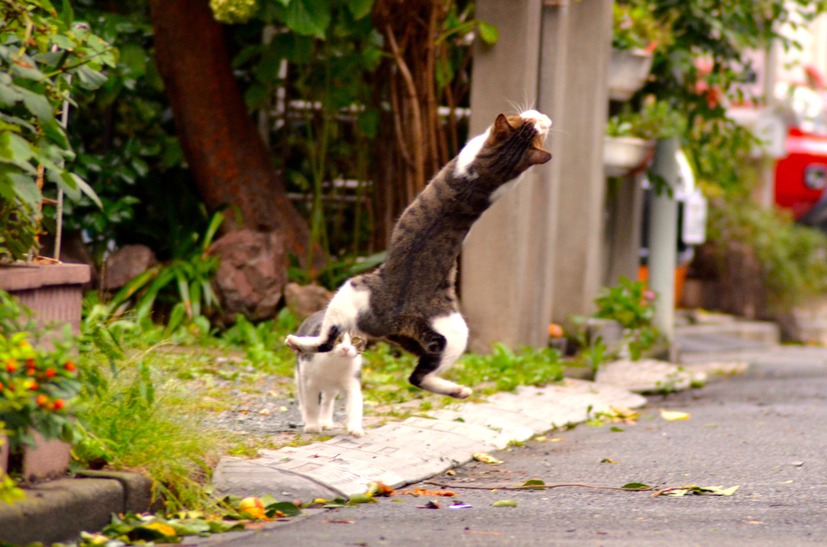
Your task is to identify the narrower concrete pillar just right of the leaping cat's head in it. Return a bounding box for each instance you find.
[552,0,612,323]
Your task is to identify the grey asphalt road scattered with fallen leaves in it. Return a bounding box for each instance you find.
[209,348,827,546]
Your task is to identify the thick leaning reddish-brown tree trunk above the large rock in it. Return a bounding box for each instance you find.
[149,0,316,262]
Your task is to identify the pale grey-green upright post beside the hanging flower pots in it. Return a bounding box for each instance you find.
[649,137,680,343]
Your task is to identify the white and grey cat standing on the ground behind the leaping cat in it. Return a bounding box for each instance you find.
[296,311,365,437]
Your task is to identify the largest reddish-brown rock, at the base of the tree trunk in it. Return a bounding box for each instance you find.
[209,230,287,322]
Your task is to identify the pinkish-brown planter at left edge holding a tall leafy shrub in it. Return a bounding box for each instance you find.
[0,264,92,344]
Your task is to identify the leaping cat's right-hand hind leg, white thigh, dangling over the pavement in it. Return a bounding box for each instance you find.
[408,312,473,399]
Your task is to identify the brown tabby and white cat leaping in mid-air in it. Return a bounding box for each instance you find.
[285,110,551,399]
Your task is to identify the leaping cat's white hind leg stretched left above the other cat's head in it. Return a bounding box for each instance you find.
[284,280,370,353]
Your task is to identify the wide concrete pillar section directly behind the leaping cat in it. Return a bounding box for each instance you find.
[460,0,548,352]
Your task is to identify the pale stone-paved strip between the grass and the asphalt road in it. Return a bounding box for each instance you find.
[213,379,646,500]
